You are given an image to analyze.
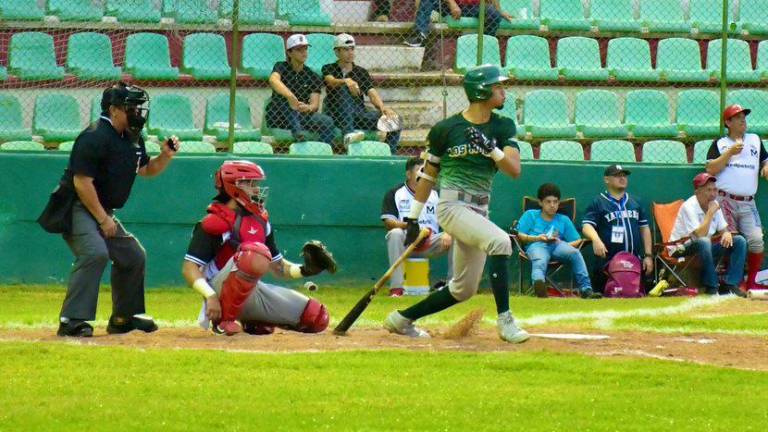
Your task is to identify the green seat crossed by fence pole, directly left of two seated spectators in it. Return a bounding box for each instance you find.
[204,93,261,142]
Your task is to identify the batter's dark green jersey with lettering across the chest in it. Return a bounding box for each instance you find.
[427,113,520,194]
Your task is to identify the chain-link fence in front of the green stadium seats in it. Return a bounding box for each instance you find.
[0,0,768,159]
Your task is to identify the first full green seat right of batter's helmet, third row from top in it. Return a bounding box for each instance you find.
[523,90,576,138]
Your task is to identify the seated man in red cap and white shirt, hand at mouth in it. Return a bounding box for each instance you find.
[669,173,747,297]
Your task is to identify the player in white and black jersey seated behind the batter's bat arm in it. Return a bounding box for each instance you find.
[381,157,452,297]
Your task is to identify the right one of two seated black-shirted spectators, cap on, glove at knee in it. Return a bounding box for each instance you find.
[322,33,400,153]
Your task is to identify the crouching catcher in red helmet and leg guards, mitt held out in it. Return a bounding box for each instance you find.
[182,161,336,336]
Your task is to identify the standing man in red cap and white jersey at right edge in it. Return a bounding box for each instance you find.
[707,105,768,290]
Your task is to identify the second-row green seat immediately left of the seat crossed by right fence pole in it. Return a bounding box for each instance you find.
[656,38,710,82]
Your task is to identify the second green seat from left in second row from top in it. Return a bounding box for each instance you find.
[67,32,123,81]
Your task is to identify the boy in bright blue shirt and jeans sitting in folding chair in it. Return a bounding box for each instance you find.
[518,183,602,299]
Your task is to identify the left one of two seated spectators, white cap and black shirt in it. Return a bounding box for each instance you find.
[266,34,334,144]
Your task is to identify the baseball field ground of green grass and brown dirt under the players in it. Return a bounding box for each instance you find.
[0,286,768,431]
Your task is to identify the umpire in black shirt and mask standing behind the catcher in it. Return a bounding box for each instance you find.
[57,82,179,337]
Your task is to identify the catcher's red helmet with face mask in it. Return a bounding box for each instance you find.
[214,160,269,214]
